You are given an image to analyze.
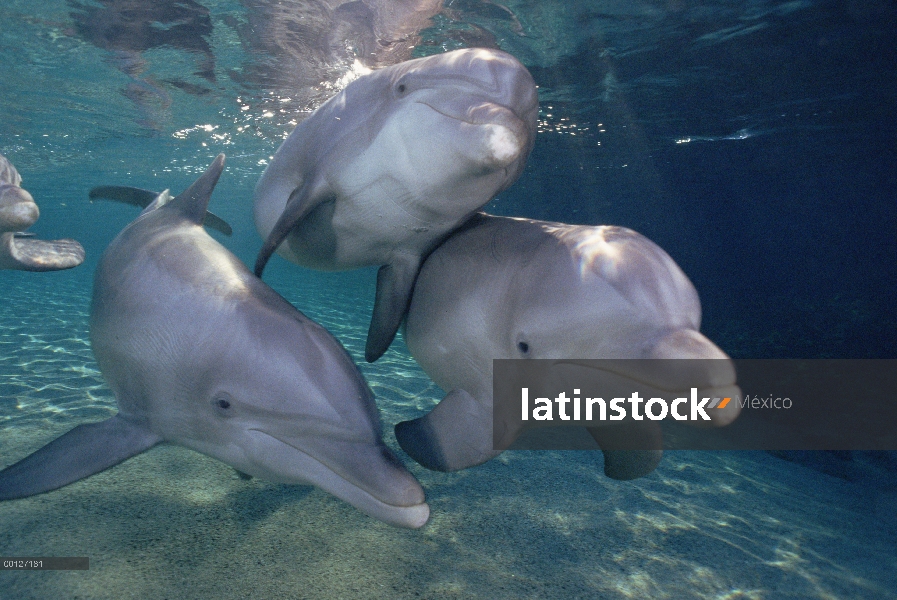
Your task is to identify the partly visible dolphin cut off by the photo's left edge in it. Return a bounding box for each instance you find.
[0,154,84,271]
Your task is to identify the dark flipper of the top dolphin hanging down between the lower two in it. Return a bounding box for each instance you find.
[364,256,420,362]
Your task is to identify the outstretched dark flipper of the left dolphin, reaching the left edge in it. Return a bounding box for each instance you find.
[0,415,162,500]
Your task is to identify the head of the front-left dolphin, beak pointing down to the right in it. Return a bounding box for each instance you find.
[152,294,429,527]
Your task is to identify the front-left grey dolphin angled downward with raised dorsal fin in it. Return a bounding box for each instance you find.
[0,155,429,528]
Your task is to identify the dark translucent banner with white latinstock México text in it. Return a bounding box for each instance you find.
[492,359,897,451]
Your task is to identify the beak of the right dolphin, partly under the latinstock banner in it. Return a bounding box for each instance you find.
[555,329,741,427]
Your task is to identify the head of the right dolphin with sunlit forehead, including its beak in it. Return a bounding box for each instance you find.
[506,223,739,426]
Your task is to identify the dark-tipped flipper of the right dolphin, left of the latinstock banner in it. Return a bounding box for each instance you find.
[395,390,501,471]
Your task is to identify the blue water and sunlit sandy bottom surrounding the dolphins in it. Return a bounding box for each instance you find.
[0,0,897,598]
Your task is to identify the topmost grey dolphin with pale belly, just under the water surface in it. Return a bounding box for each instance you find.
[248,49,539,362]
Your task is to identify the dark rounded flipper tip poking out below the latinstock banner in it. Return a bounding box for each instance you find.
[586,422,663,480]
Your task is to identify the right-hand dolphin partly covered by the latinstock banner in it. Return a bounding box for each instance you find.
[395,213,740,479]
